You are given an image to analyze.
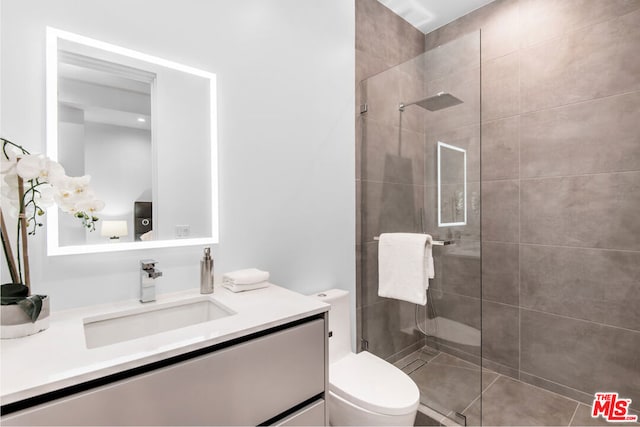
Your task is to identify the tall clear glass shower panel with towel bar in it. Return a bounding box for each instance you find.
[357,32,482,424]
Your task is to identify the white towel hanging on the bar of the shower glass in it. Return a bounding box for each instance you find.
[378,233,435,305]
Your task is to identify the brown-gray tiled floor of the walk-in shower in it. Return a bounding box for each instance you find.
[404,347,616,427]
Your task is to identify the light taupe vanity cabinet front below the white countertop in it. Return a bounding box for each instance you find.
[2,313,327,426]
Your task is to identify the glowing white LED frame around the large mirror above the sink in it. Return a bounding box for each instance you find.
[46,27,219,256]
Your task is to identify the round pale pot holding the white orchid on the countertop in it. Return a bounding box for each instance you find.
[0,283,51,339]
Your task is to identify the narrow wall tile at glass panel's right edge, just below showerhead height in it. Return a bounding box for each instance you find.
[482,116,520,181]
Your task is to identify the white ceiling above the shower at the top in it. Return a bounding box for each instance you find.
[378,0,493,34]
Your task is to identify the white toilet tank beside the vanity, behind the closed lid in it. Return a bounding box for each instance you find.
[315,289,351,363]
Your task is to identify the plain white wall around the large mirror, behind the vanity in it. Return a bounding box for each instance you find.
[0,0,355,310]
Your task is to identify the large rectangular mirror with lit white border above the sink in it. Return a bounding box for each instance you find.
[47,28,218,255]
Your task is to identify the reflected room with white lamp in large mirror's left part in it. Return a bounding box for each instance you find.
[58,50,155,246]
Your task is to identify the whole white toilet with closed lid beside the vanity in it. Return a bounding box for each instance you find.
[316,289,420,426]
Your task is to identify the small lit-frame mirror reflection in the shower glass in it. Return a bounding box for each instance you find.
[438,142,467,227]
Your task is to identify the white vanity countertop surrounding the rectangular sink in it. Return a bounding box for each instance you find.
[0,285,329,405]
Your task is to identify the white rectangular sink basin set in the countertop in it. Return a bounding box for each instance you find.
[84,297,236,348]
